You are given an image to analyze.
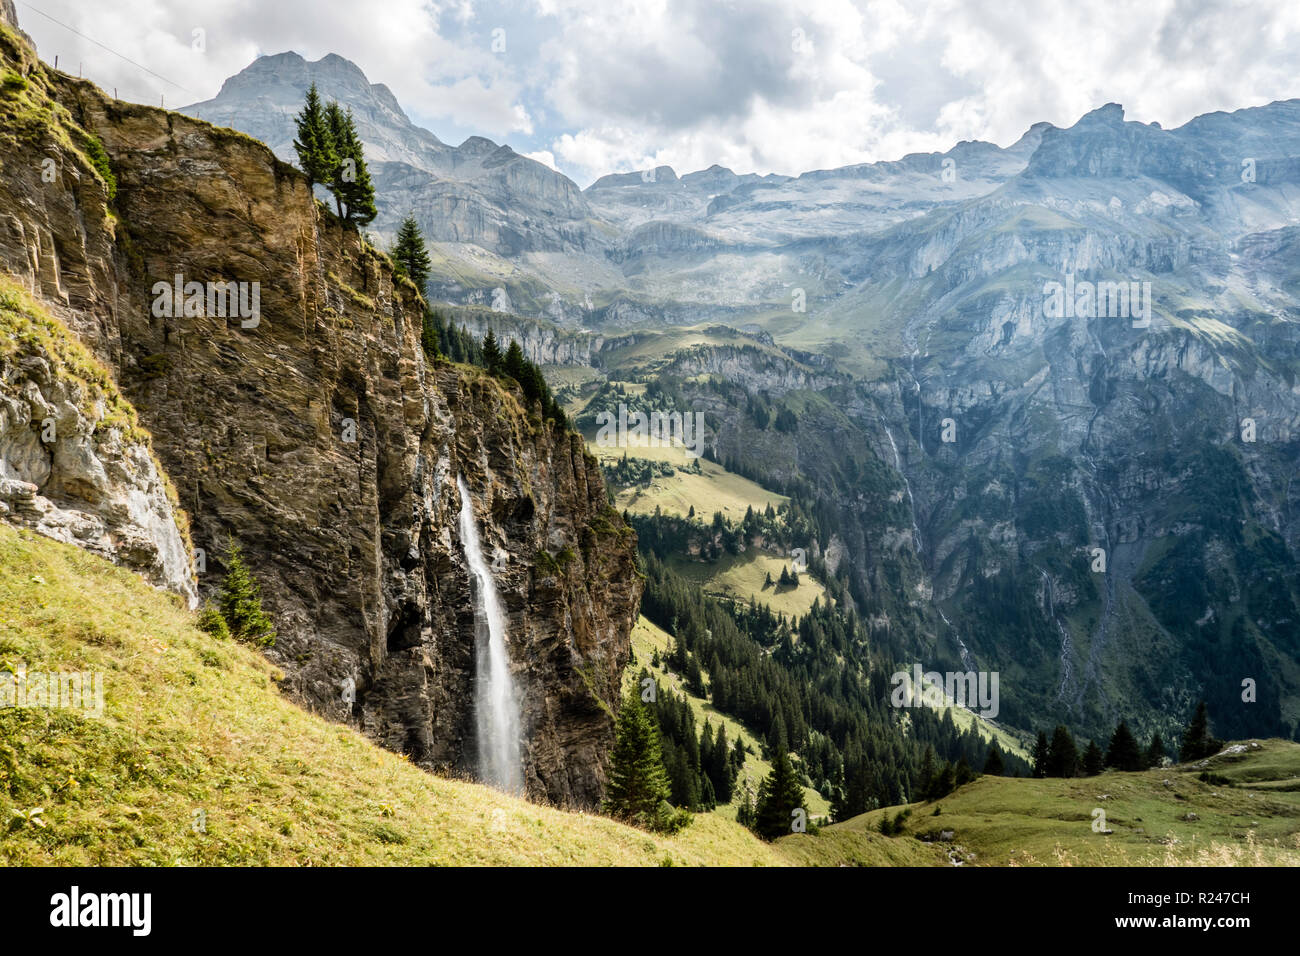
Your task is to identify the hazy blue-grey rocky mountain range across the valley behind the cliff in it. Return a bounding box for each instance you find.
[186,53,1300,736]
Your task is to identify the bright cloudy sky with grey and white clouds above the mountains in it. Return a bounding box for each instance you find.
[16,0,1300,186]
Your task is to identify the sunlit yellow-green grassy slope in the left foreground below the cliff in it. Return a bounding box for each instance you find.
[0,524,783,866]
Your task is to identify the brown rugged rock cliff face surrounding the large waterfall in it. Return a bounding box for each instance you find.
[0,14,640,805]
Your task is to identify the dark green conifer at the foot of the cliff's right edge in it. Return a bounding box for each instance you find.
[605,691,680,832]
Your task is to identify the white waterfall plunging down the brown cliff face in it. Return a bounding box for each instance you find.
[456,475,524,793]
